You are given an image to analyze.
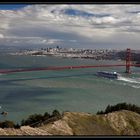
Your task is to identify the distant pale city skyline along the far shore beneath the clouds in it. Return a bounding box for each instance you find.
[10,46,140,61]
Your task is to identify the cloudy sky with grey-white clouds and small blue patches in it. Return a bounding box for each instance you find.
[0,4,140,49]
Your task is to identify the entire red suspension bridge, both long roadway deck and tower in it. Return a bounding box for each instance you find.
[0,48,140,74]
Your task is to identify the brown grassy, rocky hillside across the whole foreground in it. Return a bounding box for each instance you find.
[0,110,140,136]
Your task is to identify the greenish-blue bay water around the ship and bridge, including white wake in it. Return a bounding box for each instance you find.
[0,55,140,122]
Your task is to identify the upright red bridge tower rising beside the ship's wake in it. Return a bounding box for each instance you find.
[125,48,131,74]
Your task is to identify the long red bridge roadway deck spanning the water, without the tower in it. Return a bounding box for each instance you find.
[0,64,140,74]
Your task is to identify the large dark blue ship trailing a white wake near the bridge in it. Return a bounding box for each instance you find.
[97,71,119,79]
